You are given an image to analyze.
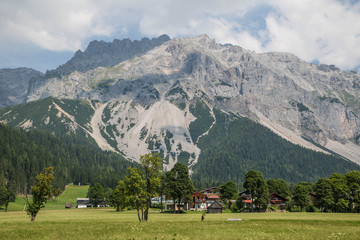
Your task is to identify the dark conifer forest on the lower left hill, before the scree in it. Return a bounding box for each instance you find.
[0,124,137,193]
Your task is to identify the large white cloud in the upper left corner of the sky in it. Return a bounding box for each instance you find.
[0,0,114,51]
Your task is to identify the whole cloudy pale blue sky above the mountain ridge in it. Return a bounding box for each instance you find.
[0,0,360,72]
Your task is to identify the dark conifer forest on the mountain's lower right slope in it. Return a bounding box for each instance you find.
[192,109,360,188]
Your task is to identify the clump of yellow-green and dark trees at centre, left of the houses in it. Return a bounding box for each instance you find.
[101,153,194,222]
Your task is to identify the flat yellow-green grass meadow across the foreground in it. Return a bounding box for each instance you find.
[0,208,360,239]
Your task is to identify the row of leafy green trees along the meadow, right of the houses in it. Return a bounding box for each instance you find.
[229,170,360,213]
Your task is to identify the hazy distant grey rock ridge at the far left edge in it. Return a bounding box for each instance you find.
[0,68,43,108]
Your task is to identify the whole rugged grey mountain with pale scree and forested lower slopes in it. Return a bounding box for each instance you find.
[0,35,360,184]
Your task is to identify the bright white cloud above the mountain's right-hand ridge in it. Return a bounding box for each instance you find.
[264,0,360,69]
